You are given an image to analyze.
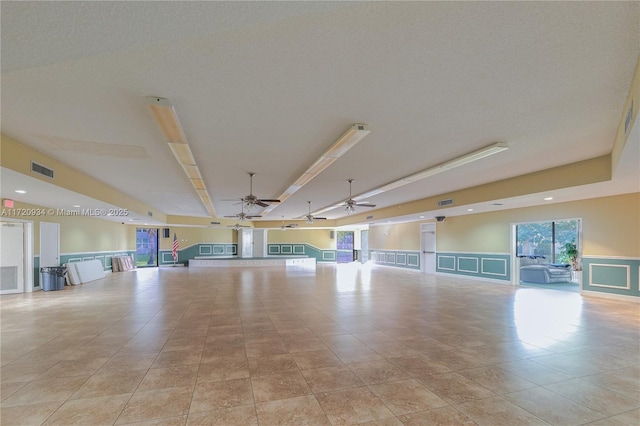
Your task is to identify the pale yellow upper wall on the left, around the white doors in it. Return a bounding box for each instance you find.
[1,202,131,256]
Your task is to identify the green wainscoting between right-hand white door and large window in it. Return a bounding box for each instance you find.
[436,252,511,281]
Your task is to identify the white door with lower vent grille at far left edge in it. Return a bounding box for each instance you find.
[0,222,24,294]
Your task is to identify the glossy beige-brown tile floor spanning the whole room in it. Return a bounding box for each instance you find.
[0,264,640,426]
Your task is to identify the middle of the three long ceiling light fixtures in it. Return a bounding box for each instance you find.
[261,123,371,215]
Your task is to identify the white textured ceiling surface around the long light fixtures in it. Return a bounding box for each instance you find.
[1,2,640,220]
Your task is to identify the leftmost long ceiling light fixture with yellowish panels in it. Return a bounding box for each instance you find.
[146,96,216,217]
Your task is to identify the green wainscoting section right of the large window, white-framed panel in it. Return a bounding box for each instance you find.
[582,257,640,297]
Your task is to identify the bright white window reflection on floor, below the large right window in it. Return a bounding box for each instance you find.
[513,288,582,348]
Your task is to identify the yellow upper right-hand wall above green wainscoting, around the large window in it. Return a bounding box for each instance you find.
[369,193,640,257]
